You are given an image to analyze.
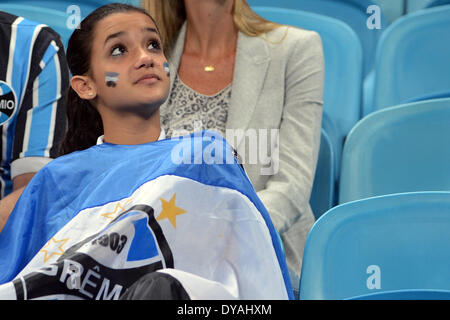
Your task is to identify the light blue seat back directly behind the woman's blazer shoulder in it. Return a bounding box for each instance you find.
[253,7,362,181]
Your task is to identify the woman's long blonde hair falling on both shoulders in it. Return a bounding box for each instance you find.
[142,0,280,56]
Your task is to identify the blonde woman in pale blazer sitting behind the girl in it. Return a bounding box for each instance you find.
[142,0,324,287]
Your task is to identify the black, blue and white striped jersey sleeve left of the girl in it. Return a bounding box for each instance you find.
[11,26,69,179]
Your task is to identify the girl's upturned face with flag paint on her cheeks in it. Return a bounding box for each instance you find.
[85,12,170,115]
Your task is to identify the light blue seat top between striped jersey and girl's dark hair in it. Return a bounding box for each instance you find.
[0,1,73,48]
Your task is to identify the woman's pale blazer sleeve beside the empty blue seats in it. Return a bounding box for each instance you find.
[258,29,324,233]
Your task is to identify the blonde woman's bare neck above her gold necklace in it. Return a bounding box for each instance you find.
[184,0,238,59]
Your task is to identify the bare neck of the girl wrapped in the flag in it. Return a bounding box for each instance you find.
[102,110,161,145]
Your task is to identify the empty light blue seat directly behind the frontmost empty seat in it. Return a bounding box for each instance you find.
[339,98,450,203]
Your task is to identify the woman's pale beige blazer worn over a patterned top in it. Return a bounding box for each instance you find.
[161,23,324,276]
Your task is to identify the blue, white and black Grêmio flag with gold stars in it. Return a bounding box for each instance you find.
[0,131,293,299]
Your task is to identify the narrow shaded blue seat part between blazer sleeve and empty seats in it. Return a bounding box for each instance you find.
[309,129,335,220]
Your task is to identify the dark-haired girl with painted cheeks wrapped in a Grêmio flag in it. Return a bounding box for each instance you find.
[0,4,293,299]
